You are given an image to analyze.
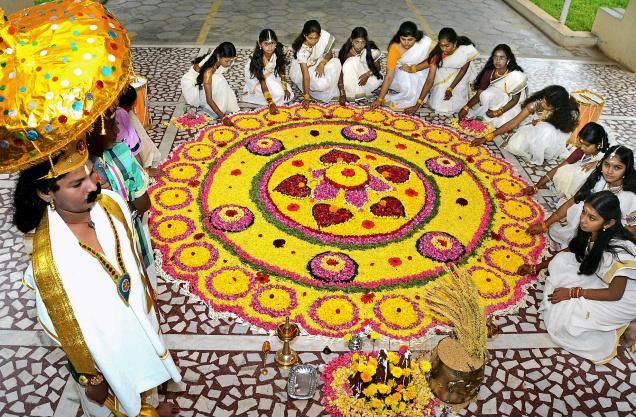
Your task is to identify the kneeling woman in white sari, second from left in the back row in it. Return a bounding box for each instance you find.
[243,29,294,114]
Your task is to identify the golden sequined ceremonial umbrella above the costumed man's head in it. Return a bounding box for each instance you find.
[0,0,131,175]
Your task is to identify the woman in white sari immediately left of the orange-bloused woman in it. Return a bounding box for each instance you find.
[338,27,382,106]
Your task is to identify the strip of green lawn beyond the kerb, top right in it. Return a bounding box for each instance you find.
[531,0,636,31]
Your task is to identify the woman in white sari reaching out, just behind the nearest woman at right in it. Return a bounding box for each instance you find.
[528,145,636,250]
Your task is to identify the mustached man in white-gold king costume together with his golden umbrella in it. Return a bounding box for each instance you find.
[0,0,181,417]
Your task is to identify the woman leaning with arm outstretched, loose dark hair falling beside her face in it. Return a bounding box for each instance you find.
[472,85,579,165]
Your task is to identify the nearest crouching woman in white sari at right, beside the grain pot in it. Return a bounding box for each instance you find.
[519,191,636,364]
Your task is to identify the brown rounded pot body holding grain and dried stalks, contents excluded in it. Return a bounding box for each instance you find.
[427,339,486,404]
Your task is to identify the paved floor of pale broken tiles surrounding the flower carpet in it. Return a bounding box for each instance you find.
[0,0,636,417]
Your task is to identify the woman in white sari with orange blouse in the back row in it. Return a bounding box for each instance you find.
[371,21,431,111]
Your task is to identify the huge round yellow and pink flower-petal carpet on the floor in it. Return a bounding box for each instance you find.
[150,104,544,339]
